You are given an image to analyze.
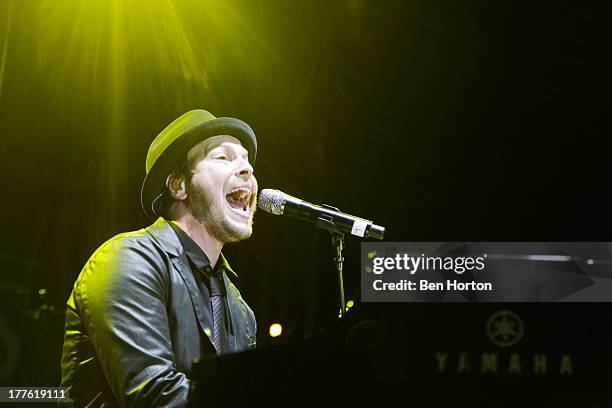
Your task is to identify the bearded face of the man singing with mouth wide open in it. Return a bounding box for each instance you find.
[186,135,257,243]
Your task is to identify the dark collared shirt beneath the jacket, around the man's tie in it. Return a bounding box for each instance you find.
[170,222,233,338]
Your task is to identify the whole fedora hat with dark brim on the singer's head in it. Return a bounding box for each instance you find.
[140,109,257,220]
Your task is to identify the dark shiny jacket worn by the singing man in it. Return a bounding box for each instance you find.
[62,218,256,407]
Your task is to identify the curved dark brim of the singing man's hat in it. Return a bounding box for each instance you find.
[140,118,257,220]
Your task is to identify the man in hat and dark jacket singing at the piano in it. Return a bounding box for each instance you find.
[62,110,257,407]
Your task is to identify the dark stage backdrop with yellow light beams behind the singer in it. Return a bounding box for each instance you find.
[0,0,612,385]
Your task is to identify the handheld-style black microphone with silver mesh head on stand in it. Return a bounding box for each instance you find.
[257,188,385,239]
